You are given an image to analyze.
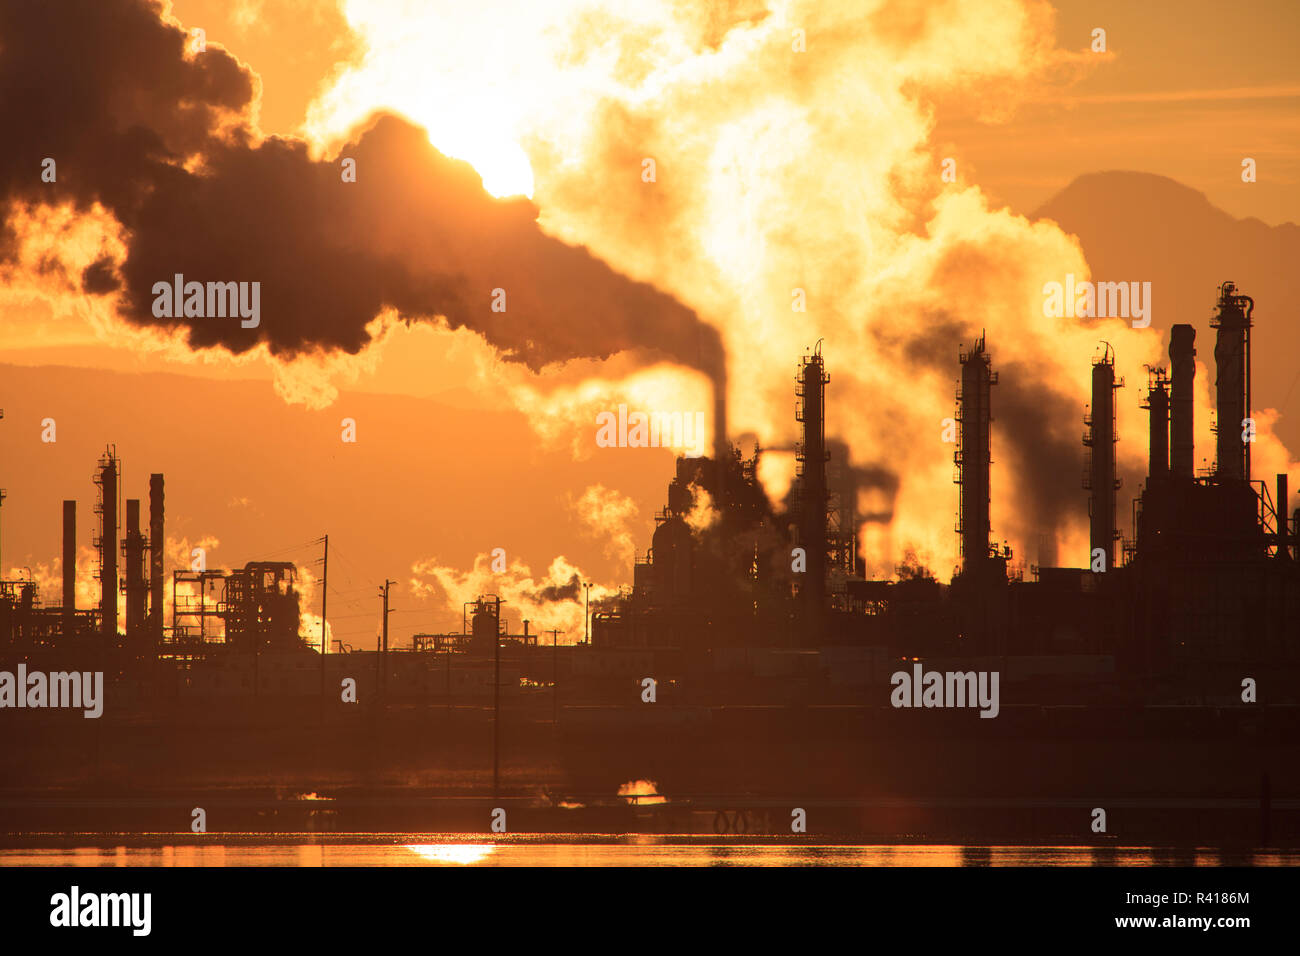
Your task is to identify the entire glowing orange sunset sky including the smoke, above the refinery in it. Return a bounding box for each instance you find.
[0,0,1300,643]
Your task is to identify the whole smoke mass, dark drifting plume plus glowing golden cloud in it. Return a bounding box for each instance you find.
[0,0,1287,574]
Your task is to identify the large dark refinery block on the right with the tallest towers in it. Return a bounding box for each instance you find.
[593,282,1300,698]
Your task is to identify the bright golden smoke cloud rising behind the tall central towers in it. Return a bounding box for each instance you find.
[377,0,1196,576]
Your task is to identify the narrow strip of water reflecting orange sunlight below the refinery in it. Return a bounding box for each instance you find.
[0,834,1300,866]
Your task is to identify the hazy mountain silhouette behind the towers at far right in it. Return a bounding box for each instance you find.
[1034,172,1300,463]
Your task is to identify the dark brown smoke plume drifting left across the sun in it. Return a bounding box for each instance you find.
[0,0,723,380]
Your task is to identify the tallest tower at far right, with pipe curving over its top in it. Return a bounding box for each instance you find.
[1210,282,1255,481]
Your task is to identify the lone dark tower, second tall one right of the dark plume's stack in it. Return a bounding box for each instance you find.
[953,332,997,575]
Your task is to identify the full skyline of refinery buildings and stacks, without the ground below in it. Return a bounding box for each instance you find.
[0,282,1300,698]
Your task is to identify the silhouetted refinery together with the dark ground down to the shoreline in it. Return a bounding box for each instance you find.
[0,282,1300,832]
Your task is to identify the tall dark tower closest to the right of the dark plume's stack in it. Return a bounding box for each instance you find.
[794,341,831,620]
